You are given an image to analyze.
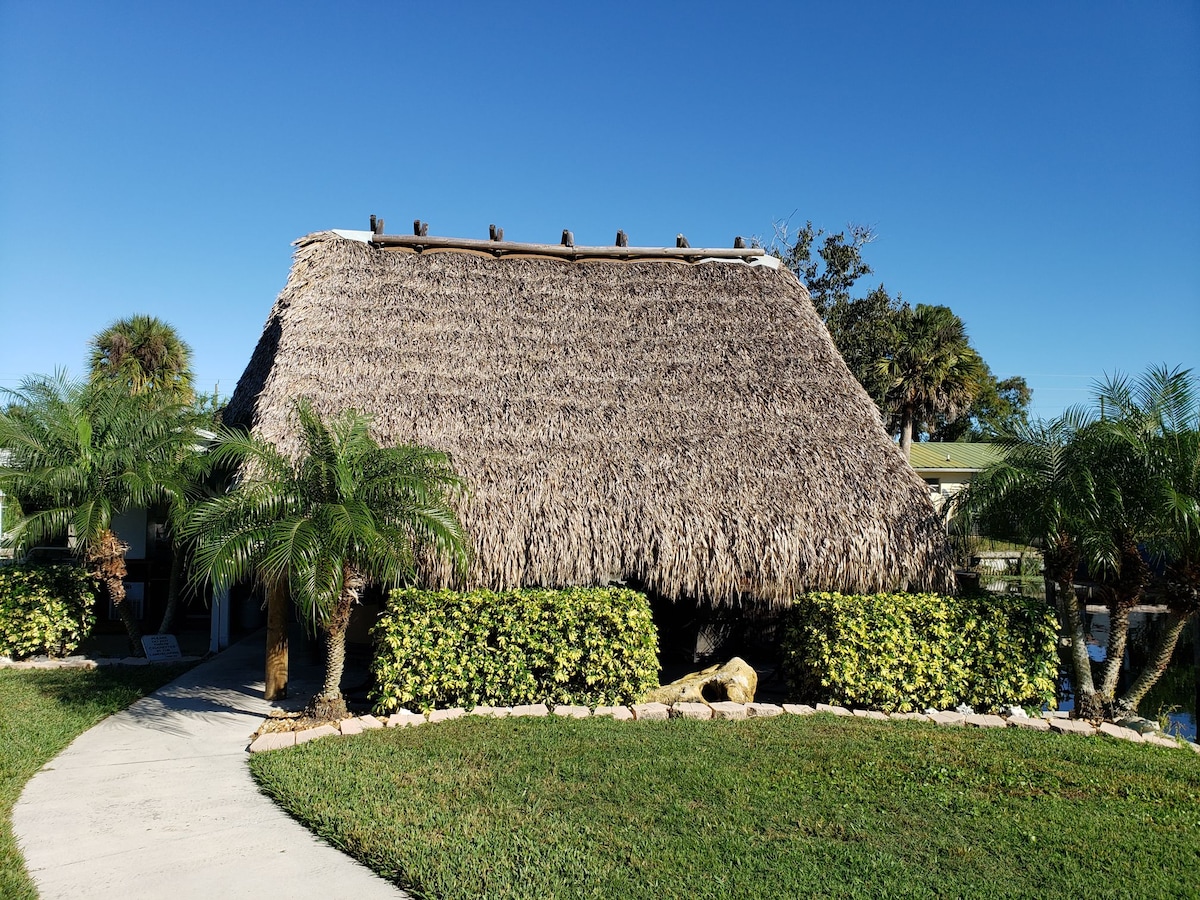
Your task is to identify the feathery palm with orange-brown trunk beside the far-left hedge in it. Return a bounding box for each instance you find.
[0,373,196,655]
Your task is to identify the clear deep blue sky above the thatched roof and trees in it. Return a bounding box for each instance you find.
[0,0,1200,416]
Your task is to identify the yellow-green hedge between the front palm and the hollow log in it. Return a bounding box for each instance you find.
[372,588,659,713]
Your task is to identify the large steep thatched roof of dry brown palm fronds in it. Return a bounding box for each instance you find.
[226,232,947,602]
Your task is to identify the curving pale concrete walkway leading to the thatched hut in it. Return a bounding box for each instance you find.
[13,634,407,900]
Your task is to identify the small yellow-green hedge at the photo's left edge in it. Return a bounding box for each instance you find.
[0,563,96,659]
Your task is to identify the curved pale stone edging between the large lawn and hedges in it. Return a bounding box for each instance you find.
[247,701,1200,754]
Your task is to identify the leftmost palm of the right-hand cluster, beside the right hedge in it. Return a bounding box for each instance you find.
[953,416,1100,719]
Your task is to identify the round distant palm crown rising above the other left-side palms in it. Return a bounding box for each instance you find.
[90,316,194,403]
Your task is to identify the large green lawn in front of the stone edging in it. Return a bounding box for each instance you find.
[251,715,1200,900]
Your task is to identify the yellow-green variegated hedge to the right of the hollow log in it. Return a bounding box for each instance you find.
[781,593,1057,712]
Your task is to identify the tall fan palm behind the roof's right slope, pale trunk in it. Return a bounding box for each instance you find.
[877,304,985,458]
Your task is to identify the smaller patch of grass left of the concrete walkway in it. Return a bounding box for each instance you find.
[0,664,191,899]
